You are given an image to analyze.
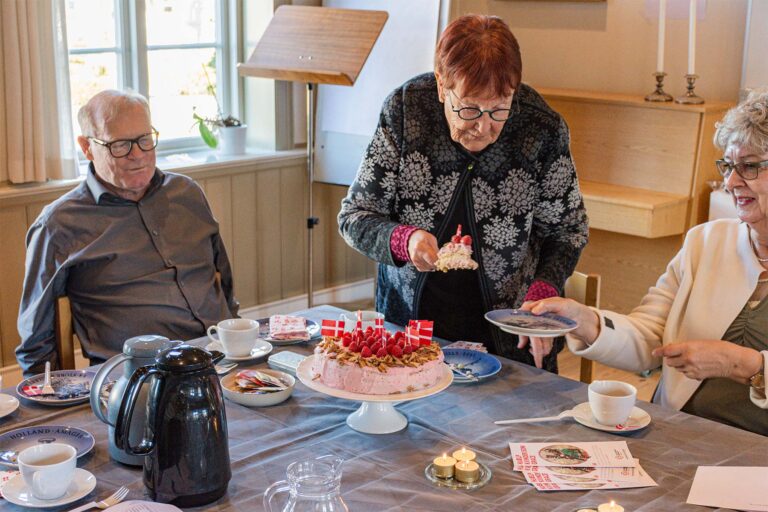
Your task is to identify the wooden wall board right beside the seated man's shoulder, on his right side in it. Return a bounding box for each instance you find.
[227,173,262,308]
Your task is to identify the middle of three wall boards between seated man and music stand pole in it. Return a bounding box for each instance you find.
[255,169,284,304]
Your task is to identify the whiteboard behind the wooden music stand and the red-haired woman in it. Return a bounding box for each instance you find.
[315,0,440,185]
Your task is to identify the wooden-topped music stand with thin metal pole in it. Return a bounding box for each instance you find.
[237,5,389,308]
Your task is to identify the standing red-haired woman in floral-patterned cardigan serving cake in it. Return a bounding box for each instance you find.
[338,15,588,372]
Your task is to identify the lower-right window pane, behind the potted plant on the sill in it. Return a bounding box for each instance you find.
[147,48,219,141]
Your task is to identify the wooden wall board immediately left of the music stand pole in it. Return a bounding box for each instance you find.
[279,166,309,298]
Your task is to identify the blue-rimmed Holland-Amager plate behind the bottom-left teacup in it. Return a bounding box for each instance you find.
[0,425,95,466]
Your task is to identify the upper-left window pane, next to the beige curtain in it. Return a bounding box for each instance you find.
[67,0,115,50]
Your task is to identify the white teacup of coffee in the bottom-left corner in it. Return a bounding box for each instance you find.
[17,443,77,500]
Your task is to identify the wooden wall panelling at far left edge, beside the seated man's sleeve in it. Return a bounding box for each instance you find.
[0,205,27,366]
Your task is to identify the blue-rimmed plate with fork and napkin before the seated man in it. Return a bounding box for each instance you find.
[16,370,96,406]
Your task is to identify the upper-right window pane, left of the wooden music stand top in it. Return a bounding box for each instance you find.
[146,0,217,46]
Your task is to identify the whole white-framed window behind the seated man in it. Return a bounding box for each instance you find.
[66,0,239,156]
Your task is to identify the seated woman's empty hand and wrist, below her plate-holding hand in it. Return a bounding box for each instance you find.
[653,340,762,384]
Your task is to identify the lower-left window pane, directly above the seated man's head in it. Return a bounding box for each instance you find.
[69,53,117,134]
